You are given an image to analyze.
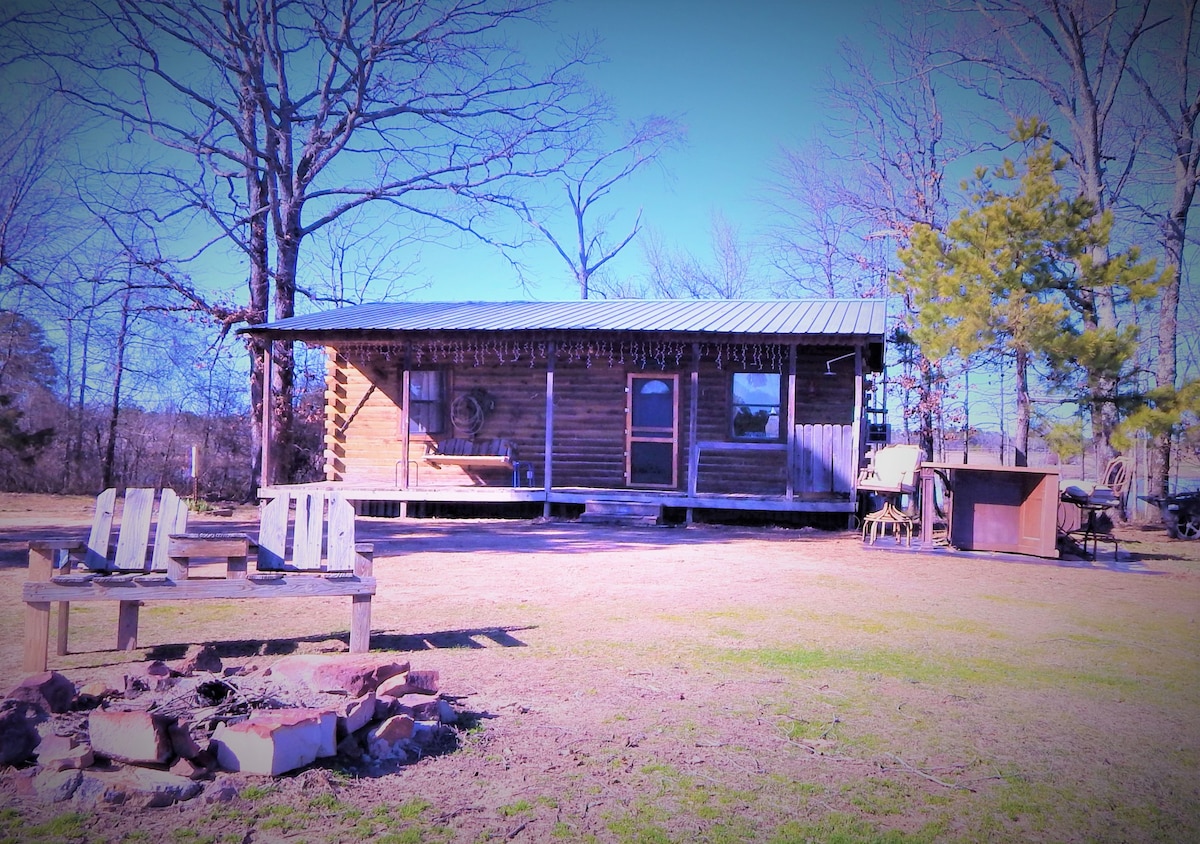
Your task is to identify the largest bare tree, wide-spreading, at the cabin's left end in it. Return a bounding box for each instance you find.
[7,0,596,485]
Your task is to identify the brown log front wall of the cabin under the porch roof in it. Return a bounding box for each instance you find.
[325,336,857,495]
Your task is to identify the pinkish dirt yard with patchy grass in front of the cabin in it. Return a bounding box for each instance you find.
[0,495,1200,844]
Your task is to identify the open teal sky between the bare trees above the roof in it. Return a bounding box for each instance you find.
[403,0,886,300]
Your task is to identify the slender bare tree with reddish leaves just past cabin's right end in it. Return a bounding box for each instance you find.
[806,13,979,455]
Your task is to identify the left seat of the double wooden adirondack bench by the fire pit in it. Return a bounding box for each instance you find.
[24,489,187,671]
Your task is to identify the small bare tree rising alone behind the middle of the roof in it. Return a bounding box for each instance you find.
[518,115,684,299]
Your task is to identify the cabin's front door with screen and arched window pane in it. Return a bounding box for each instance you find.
[625,375,679,489]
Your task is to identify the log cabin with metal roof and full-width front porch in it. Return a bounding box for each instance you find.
[244,299,887,521]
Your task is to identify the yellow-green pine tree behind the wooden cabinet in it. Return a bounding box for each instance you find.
[892,120,1162,466]
